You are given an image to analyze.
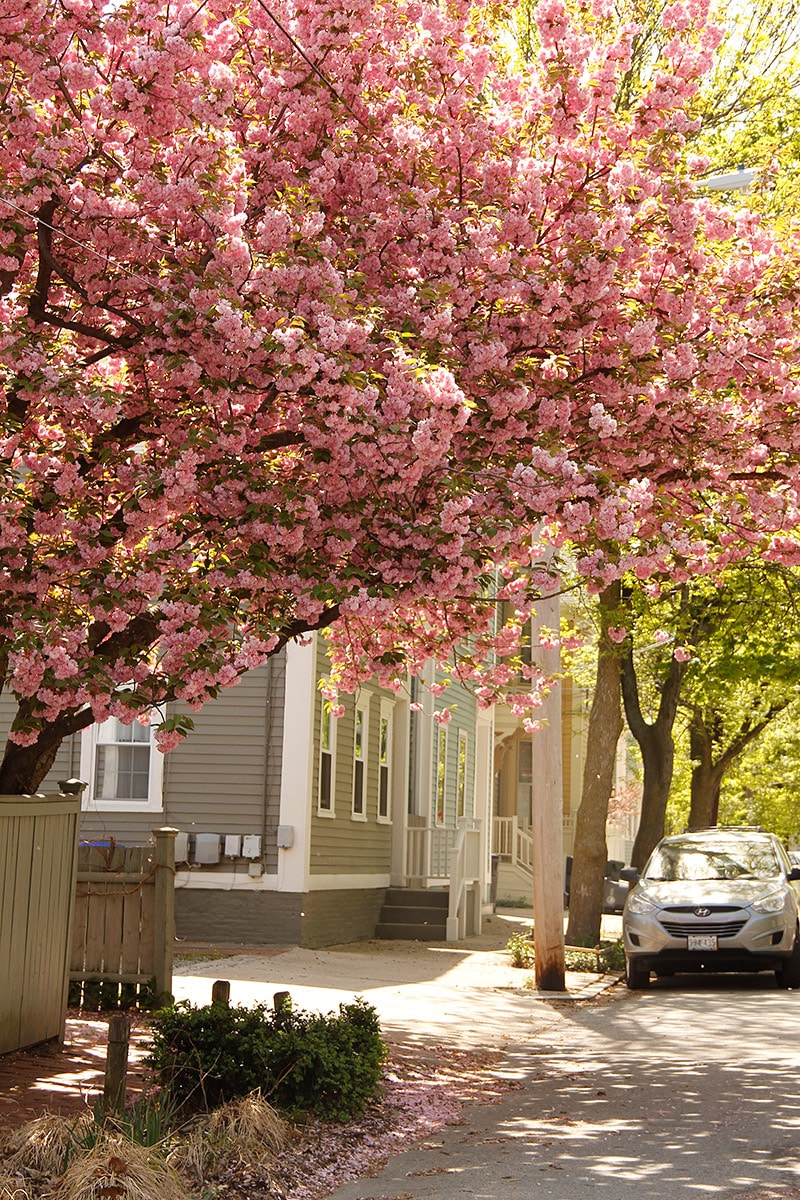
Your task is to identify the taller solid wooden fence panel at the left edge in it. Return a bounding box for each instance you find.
[0,796,80,1054]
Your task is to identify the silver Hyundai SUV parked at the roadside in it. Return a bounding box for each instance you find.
[620,827,800,989]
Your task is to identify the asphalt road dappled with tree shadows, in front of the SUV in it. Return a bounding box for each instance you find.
[330,974,800,1200]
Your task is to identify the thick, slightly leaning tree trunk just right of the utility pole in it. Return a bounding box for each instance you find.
[566,583,622,946]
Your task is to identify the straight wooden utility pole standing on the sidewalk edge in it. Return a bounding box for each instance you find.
[530,585,566,991]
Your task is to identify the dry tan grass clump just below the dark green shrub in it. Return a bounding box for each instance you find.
[169,1092,293,1180]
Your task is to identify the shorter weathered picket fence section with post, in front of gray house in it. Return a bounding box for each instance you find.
[70,829,178,1007]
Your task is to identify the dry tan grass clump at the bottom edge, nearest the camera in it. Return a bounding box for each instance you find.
[54,1139,190,1200]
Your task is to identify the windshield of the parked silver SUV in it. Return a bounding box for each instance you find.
[643,839,781,882]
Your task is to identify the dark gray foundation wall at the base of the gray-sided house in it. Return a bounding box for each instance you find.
[175,888,386,949]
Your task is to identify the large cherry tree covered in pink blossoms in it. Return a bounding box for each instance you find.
[0,0,799,792]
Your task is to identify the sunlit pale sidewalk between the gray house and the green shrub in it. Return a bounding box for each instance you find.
[173,910,619,1049]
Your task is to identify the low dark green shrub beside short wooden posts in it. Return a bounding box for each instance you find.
[148,998,386,1121]
